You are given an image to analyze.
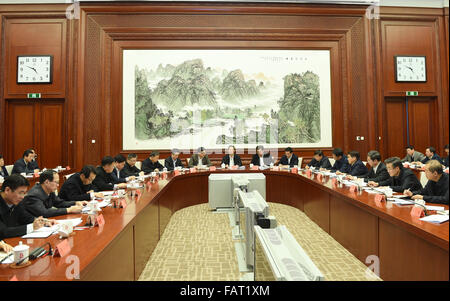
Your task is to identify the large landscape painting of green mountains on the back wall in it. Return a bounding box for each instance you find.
[123,50,332,150]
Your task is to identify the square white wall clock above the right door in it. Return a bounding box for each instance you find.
[395,56,427,82]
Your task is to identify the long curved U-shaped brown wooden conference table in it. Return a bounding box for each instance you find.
[0,167,449,281]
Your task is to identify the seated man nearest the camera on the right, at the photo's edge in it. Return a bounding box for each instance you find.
[403,160,449,205]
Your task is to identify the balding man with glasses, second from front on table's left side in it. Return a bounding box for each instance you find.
[23,169,87,217]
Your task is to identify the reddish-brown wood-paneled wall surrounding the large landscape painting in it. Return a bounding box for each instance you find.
[0,3,449,168]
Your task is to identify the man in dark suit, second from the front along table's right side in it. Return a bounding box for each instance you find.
[369,157,422,192]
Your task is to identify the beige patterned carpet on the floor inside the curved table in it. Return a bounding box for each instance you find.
[139,203,381,281]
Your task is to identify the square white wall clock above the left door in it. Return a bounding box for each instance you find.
[17,55,53,84]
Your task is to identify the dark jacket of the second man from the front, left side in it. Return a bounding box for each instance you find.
[22,183,75,217]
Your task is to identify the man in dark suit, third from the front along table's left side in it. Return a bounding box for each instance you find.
[58,165,103,202]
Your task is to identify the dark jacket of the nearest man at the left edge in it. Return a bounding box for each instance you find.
[0,195,34,239]
